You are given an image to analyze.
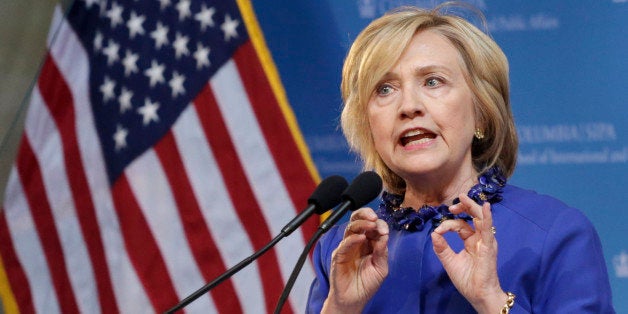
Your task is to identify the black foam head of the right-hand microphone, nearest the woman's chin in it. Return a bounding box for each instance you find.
[341,171,382,210]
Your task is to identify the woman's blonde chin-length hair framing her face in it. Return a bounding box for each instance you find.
[340,5,518,193]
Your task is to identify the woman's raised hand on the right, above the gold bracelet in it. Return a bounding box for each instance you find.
[432,195,508,313]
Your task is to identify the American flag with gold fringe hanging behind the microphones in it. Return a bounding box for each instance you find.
[0,0,319,313]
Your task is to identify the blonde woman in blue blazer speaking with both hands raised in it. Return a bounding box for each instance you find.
[308,4,614,313]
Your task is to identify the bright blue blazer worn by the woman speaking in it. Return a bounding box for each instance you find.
[307,185,615,313]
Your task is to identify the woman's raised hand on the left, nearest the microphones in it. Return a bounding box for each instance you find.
[322,207,388,313]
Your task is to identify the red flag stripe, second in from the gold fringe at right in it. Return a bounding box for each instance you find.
[194,85,292,313]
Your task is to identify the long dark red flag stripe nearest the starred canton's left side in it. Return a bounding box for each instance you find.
[39,55,118,313]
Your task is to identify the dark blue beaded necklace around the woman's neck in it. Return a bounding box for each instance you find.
[377,167,506,232]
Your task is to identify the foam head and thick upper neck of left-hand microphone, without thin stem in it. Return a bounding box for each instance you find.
[281,175,349,236]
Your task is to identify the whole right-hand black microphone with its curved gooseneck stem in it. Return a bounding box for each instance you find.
[274,171,382,314]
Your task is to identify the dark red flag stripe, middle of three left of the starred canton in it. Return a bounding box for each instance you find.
[17,136,79,313]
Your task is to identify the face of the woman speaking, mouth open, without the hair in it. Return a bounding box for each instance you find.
[367,31,475,181]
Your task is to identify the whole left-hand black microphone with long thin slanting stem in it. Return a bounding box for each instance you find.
[165,175,348,313]
